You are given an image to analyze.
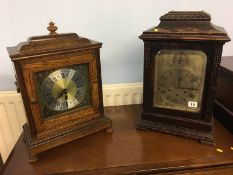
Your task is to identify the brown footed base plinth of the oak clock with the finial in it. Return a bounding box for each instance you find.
[23,116,112,162]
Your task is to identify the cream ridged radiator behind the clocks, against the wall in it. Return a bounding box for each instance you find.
[0,82,143,162]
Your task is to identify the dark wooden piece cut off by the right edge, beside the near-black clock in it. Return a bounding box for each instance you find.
[214,56,233,132]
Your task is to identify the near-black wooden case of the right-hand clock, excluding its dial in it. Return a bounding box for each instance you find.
[137,11,230,145]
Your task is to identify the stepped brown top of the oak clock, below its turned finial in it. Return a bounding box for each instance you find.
[7,33,102,59]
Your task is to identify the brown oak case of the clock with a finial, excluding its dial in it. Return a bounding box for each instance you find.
[7,23,112,162]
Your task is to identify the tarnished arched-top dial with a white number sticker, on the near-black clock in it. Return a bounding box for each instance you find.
[153,49,207,112]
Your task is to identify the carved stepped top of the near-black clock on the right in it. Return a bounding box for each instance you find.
[140,11,230,42]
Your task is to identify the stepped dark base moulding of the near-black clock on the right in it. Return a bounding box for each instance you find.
[137,114,215,145]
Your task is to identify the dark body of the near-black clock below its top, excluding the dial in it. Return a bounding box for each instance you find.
[138,40,223,145]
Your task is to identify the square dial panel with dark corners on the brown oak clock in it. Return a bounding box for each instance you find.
[36,64,90,118]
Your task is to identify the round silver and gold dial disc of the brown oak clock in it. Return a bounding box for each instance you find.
[42,69,84,111]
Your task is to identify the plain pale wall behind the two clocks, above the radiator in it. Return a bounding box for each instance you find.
[0,0,233,90]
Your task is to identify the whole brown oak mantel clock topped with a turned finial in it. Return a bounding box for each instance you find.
[7,22,111,161]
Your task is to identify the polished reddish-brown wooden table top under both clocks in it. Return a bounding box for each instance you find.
[3,105,233,175]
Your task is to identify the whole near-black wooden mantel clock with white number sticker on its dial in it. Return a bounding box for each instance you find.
[138,11,230,145]
